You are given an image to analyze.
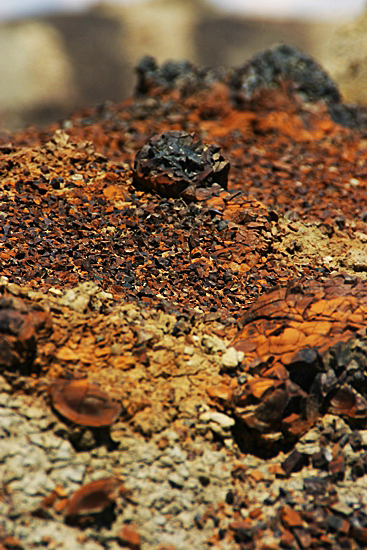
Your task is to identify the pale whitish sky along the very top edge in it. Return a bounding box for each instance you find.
[0,0,366,21]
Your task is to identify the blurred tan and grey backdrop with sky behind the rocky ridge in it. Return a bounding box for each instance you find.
[0,0,367,130]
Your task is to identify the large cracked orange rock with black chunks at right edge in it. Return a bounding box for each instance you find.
[226,276,367,448]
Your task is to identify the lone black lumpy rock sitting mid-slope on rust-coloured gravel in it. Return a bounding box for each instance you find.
[133,131,230,200]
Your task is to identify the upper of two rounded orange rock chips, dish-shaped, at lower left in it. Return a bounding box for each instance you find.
[51,379,121,428]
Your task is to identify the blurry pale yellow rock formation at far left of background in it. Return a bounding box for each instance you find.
[0,21,76,127]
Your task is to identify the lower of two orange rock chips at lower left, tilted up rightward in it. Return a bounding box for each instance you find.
[65,477,119,517]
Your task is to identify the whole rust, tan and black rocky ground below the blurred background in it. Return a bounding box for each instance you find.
[0,47,367,550]
